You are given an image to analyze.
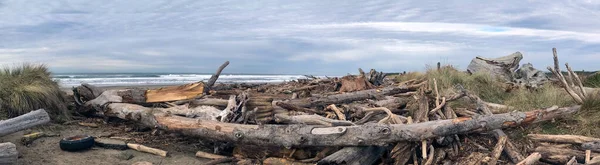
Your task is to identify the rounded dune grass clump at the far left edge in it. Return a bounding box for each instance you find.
[0,64,70,120]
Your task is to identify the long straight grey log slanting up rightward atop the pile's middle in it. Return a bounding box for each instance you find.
[289,82,425,107]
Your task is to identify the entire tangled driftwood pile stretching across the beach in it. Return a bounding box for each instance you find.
[69,48,598,165]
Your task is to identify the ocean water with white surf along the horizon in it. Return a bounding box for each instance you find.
[52,73,306,88]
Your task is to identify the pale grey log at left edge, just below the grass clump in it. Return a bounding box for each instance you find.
[0,109,50,137]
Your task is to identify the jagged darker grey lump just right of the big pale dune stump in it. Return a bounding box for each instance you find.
[513,63,549,88]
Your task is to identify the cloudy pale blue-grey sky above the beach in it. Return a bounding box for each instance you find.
[0,0,600,75]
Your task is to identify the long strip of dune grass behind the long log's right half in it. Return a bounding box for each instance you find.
[397,66,575,111]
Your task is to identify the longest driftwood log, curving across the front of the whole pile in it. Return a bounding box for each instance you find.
[86,89,580,147]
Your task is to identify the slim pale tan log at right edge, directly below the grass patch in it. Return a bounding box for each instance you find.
[527,134,600,144]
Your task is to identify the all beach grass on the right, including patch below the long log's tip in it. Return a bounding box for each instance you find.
[394,66,600,137]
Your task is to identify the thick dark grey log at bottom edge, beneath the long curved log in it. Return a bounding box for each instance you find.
[317,146,385,165]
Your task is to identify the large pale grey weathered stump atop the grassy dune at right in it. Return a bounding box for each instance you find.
[467,52,523,82]
